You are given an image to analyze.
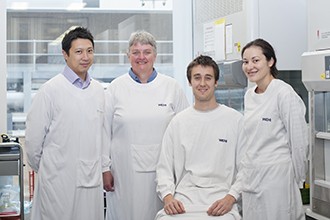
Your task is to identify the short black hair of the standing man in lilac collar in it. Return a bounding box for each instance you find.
[62,27,94,55]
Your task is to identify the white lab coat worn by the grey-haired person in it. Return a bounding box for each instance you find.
[105,73,189,220]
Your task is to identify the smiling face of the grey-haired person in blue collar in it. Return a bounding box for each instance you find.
[128,42,157,76]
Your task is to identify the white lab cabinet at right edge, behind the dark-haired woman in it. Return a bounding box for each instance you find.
[302,50,330,220]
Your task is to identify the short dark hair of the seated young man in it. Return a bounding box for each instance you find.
[187,55,220,83]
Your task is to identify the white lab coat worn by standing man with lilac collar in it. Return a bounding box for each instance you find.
[25,74,104,220]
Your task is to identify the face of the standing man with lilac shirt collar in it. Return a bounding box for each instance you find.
[62,38,94,80]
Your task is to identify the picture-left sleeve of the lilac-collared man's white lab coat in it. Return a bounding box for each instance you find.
[25,87,53,172]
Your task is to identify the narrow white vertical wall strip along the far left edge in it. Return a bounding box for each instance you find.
[0,1,7,133]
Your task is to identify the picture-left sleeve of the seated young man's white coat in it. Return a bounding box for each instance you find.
[156,123,175,201]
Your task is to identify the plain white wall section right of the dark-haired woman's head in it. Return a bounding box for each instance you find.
[258,0,306,70]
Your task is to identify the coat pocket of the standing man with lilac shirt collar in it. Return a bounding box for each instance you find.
[77,160,102,188]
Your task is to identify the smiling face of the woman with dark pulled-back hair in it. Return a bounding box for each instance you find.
[242,46,274,86]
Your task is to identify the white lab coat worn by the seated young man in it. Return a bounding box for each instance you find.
[156,105,245,220]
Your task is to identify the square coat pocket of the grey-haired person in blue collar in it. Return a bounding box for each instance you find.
[132,144,160,172]
